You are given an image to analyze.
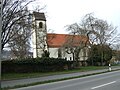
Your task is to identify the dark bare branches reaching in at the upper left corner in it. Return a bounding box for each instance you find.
[1,0,34,49]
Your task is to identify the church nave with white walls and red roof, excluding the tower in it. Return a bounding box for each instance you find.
[47,33,88,61]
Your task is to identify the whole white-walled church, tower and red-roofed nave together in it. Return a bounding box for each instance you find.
[32,12,89,61]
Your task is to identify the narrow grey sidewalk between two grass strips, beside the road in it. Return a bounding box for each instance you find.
[1,66,120,88]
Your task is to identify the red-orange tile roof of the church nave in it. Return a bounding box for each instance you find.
[47,33,88,48]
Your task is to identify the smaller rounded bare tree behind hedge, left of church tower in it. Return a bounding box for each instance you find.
[9,33,30,58]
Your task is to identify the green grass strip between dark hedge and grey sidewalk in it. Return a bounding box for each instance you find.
[1,66,108,80]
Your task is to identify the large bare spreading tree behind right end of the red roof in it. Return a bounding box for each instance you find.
[64,13,116,65]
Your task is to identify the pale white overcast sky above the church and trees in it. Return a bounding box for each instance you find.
[28,0,120,33]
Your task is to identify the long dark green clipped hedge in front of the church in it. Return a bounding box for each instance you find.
[1,58,73,73]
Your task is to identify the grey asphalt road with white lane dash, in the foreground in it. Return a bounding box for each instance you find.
[12,71,120,90]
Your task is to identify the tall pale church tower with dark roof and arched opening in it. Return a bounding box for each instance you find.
[32,12,47,58]
